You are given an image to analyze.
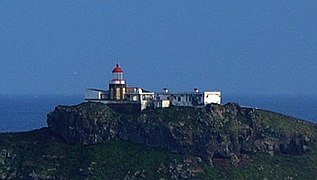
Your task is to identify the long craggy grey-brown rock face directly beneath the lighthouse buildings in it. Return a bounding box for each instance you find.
[47,103,311,164]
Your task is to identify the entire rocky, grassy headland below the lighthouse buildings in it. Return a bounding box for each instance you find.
[0,103,317,179]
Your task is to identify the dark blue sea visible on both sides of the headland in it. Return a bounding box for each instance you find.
[0,95,317,132]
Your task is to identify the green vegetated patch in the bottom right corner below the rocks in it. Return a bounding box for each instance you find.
[206,145,317,179]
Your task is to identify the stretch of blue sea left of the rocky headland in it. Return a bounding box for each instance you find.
[0,95,84,132]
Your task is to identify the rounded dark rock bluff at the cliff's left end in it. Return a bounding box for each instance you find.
[47,103,120,145]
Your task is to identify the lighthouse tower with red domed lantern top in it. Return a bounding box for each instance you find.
[109,64,127,101]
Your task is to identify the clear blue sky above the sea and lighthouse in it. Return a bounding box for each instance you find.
[0,0,317,95]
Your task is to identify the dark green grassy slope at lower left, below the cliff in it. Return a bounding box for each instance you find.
[0,128,182,179]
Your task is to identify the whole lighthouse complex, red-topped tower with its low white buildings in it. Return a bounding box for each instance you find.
[85,64,221,111]
